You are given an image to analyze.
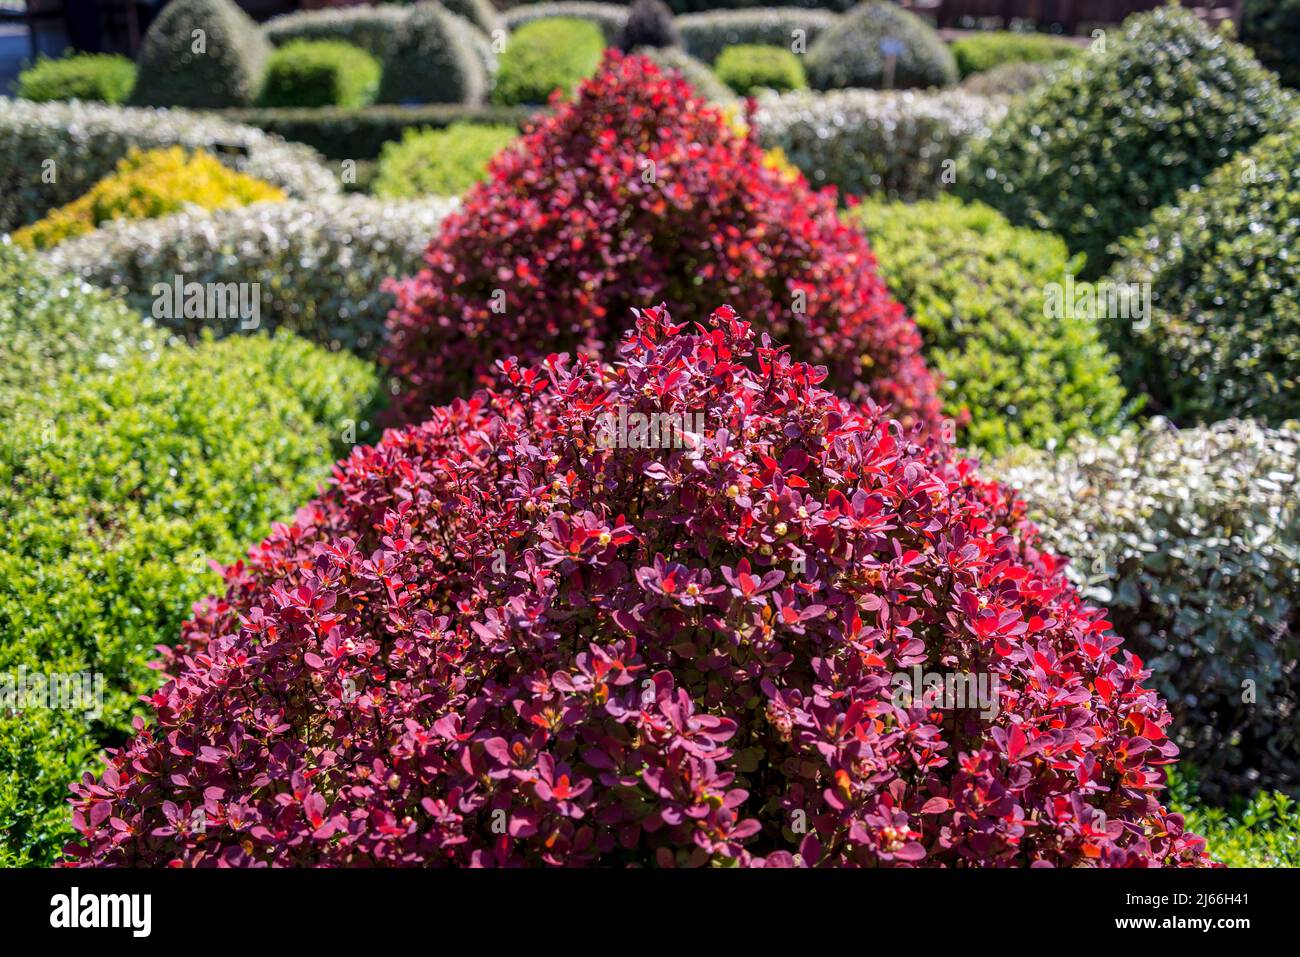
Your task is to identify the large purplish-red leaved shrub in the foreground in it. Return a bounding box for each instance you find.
[70,308,1206,866]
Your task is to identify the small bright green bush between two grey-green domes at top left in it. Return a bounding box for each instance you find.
[259,40,382,108]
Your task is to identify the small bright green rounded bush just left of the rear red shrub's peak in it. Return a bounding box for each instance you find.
[491,17,605,105]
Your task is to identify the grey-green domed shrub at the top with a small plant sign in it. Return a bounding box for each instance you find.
[807,0,957,90]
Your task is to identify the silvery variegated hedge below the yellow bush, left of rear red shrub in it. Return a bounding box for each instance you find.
[49,196,455,356]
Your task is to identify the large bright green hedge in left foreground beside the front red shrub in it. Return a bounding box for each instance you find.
[0,323,377,866]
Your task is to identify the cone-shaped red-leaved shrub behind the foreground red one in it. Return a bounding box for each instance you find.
[382,52,940,426]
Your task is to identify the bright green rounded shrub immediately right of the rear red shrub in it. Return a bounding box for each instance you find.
[852,198,1125,454]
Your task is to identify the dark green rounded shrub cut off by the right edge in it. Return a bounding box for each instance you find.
[1112,124,1300,424]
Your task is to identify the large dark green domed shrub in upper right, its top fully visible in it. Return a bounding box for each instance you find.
[956,7,1292,278]
